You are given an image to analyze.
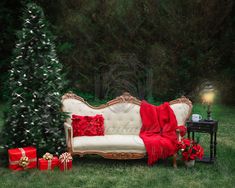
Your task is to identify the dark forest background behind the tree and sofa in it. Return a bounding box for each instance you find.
[0,0,235,104]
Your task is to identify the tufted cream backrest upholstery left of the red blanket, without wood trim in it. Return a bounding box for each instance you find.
[63,99,142,135]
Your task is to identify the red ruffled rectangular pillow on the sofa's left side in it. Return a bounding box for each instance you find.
[72,114,104,137]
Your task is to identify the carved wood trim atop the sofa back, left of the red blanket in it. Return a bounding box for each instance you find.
[62,92,141,109]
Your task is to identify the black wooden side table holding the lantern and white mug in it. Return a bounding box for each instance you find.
[186,120,218,163]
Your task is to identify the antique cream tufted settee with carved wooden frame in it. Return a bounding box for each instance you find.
[62,93,192,165]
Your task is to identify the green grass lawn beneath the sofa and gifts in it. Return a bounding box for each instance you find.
[0,105,235,188]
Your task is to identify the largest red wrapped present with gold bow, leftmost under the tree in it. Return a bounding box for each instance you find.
[8,147,37,170]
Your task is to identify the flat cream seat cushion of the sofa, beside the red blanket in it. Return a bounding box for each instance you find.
[73,135,146,153]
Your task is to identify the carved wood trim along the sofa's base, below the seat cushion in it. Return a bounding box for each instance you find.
[72,151,146,160]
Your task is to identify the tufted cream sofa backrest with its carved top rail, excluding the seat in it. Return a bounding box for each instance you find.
[62,94,191,135]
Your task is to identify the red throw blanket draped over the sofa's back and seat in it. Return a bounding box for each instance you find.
[140,101,177,165]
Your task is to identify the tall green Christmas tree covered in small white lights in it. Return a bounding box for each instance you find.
[3,3,65,154]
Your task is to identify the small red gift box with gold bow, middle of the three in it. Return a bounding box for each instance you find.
[38,153,59,170]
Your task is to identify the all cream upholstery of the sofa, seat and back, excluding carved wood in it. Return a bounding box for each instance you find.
[63,99,190,153]
